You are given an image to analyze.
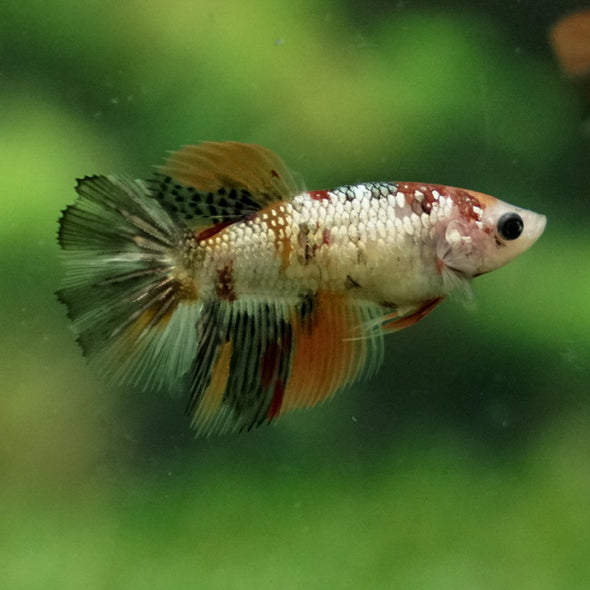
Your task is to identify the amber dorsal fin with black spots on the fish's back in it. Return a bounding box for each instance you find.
[146,141,298,229]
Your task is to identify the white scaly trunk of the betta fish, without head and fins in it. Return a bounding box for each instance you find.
[194,182,453,305]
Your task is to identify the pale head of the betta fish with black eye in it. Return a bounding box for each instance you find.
[439,191,547,278]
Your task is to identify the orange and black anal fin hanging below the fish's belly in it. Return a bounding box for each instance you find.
[188,293,383,435]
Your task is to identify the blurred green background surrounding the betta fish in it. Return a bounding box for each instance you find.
[0,0,590,590]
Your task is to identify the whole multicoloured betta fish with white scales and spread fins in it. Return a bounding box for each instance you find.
[57,141,546,436]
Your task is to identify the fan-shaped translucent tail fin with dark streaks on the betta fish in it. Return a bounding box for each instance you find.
[57,176,200,396]
